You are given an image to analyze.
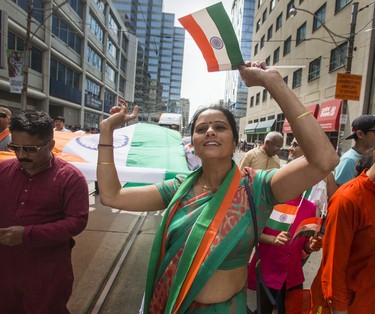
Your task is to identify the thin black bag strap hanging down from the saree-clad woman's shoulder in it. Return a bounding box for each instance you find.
[245,175,276,314]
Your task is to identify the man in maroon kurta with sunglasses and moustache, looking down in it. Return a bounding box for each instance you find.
[0,112,89,314]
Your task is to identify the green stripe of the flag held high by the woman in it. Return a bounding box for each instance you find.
[207,2,244,69]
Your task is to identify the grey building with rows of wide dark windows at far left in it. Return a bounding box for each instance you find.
[0,0,137,128]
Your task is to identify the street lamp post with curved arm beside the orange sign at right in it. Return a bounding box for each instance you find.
[289,2,363,156]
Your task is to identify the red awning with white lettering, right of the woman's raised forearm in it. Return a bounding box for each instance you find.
[318,99,342,132]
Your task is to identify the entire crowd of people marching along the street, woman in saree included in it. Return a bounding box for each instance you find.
[0,62,375,314]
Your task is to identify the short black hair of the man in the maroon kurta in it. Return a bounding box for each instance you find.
[9,111,55,141]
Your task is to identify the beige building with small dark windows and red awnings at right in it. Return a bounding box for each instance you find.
[240,0,375,151]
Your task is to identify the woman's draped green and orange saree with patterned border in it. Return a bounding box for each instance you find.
[144,164,274,314]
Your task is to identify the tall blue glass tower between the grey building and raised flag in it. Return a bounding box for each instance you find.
[114,0,185,122]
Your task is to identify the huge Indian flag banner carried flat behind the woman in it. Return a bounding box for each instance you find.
[0,123,189,184]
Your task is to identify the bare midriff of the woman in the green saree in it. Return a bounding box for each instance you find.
[195,266,247,304]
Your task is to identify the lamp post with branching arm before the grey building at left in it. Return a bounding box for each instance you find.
[21,0,69,111]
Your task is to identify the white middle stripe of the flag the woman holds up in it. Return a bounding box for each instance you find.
[192,10,232,71]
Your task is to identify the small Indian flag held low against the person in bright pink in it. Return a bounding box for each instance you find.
[266,204,298,231]
